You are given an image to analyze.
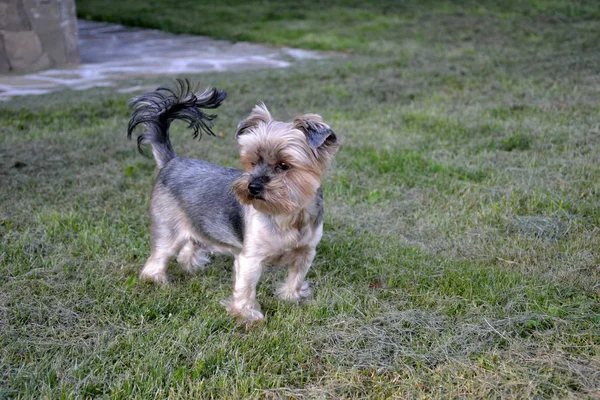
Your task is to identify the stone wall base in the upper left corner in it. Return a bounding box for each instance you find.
[0,0,79,72]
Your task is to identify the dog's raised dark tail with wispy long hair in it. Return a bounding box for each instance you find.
[127,79,227,168]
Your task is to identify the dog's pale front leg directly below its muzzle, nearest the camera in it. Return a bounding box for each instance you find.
[225,254,265,322]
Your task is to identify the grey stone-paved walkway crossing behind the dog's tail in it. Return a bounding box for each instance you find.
[0,20,321,100]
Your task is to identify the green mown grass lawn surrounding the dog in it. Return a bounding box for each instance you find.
[0,0,600,399]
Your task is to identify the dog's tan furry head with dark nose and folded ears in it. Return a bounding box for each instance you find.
[232,104,339,214]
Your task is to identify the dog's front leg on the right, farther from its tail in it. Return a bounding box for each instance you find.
[277,247,317,301]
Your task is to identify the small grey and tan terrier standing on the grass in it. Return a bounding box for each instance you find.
[128,81,339,322]
